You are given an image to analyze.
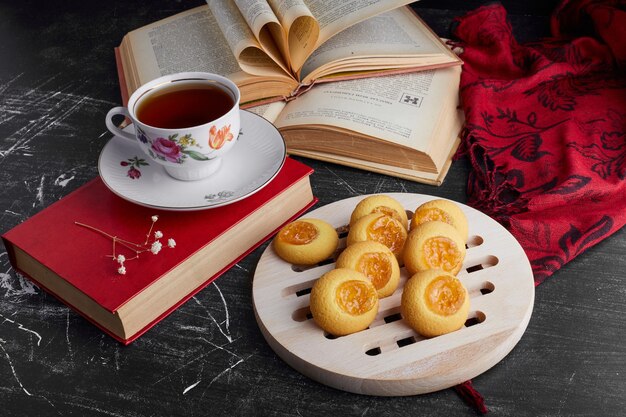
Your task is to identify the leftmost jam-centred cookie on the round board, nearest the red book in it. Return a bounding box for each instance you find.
[274,219,339,265]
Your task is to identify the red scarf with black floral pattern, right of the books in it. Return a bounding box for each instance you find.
[455,0,626,284]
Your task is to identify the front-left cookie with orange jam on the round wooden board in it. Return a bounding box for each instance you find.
[311,268,378,336]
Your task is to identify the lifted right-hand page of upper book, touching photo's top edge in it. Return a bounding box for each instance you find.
[304,0,413,45]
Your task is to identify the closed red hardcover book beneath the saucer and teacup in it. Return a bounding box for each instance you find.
[2,158,317,344]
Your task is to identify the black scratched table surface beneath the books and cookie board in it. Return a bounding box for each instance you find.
[0,0,626,417]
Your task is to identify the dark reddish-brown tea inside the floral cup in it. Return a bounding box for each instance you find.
[135,81,235,129]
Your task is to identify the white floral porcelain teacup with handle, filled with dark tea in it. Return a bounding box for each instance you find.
[106,72,241,180]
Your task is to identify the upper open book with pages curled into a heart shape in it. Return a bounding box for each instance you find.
[116,0,461,104]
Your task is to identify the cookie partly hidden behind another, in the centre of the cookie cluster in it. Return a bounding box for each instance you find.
[346,213,407,263]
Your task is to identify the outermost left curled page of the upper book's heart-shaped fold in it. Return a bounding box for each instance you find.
[206,0,290,76]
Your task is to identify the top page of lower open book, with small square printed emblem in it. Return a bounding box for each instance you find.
[275,66,460,152]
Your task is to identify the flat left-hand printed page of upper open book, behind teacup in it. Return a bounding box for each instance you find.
[128,6,247,87]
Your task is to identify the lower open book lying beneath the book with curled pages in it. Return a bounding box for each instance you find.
[250,66,464,185]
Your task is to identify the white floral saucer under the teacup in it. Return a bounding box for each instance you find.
[98,111,287,211]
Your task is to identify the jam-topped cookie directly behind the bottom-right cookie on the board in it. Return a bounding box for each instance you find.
[404,221,465,275]
